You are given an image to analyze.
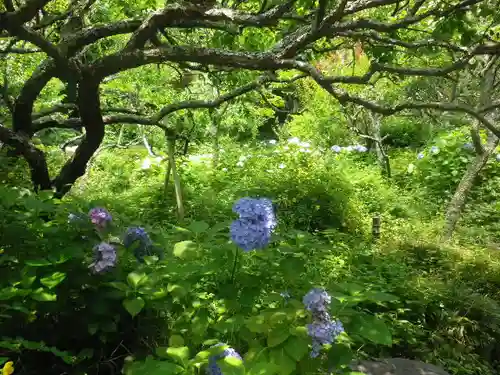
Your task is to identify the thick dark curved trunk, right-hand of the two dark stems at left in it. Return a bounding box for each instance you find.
[54,75,104,198]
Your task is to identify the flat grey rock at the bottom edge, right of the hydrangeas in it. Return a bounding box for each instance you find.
[351,358,450,375]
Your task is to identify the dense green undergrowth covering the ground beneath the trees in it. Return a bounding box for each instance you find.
[0,132,500,375]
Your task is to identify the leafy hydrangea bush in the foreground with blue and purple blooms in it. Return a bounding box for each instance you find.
[0,188,398,375]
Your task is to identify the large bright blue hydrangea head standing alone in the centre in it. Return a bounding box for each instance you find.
[230,198,277,251]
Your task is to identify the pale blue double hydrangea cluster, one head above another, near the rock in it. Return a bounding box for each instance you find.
[302,288,344,358]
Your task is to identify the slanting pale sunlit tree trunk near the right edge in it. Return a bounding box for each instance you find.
[443,139,498,241]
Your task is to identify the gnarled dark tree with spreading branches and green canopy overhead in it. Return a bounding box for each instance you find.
[0,0,500,196]
